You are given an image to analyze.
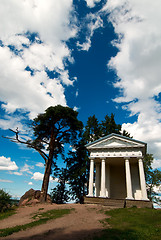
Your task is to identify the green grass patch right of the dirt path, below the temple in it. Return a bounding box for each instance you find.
[94,208,161,240]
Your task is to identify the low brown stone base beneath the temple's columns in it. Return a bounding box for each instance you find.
[84,196,153,208]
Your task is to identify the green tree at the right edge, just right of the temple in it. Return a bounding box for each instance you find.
[144,154,161,203]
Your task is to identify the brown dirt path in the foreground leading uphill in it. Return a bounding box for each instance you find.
[0,204,110,240]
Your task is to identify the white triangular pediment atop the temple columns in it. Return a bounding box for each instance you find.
[86,134,146,149]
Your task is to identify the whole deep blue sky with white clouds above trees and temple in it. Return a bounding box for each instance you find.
[0,0,161,198]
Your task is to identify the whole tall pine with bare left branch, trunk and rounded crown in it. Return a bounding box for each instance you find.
[4,105,82,202]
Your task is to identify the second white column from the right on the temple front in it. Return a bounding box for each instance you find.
[125,159,134,199]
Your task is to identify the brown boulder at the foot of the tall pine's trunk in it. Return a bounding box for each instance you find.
[19,188,52,206]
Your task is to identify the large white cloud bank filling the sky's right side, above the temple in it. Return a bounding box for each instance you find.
[103,0,161,159]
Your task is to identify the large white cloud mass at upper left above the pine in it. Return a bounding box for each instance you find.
[0,0,77,124]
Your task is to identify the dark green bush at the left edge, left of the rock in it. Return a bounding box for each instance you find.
[0,189,12,212]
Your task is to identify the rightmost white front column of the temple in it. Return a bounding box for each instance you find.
[138,159,149,200]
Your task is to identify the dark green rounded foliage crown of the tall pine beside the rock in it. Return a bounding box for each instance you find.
[28,105,83,158]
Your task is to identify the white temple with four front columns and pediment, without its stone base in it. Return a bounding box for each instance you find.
[86,134,149,201]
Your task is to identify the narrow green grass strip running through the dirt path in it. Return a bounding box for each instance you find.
[0,209,71,237]
